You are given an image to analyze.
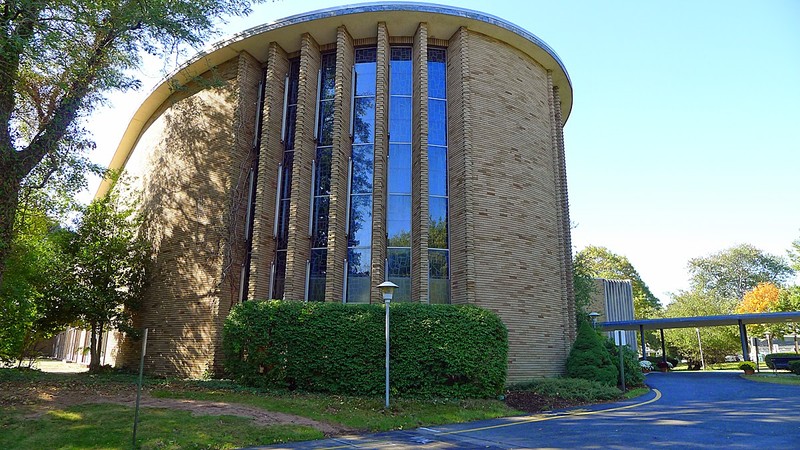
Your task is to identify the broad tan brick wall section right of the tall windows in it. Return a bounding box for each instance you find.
[460,32,572,382]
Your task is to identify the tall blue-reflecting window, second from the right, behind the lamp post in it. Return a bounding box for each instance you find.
[386,47,413,302]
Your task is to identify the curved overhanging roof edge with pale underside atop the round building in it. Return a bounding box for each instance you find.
[96,2,572,197]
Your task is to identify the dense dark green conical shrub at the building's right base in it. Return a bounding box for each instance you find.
[566,321,619,386]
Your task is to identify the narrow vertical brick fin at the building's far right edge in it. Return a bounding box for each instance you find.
[551,81,577,344]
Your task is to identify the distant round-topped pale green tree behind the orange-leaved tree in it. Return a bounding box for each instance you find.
[689,244,794,300]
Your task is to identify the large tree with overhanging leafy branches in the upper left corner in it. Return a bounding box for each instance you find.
[0,0,266,283]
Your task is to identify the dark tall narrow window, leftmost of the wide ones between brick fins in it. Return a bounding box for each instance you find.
[272,58,300,298]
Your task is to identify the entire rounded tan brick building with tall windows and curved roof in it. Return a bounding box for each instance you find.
[109,3,575,382]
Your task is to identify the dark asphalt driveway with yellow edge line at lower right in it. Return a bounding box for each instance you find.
[255,372,800,450]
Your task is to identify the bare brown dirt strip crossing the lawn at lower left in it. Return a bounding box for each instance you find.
[0,381,352,436]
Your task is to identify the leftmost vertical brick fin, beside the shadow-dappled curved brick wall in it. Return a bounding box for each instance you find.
[211,52,262,373]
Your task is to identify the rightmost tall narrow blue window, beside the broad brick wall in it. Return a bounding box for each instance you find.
[428,48,450,303]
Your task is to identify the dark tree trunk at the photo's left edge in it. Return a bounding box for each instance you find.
[0,153,22,285]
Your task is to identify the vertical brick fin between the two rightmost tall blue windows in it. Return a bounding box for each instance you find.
[411,22,429,303]
